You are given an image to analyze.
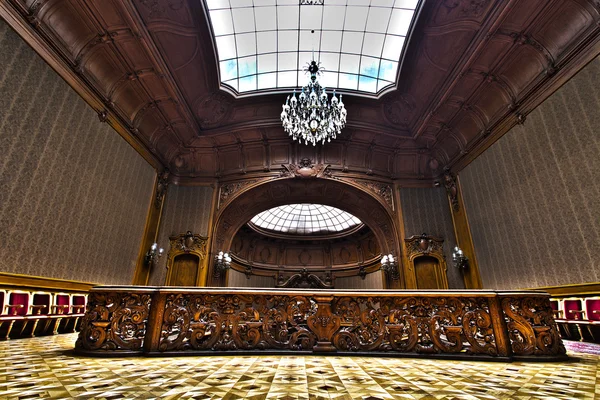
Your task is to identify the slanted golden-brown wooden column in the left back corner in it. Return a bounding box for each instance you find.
[132,169,169,285]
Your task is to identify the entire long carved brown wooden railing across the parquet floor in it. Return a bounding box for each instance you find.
[75,287,566,360]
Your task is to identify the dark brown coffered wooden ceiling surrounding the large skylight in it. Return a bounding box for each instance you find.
[0,0,600,184]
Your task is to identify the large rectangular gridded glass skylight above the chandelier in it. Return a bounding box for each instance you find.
[205,0,420,94]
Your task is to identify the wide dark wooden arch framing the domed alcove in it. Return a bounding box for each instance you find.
[209,178,404,288]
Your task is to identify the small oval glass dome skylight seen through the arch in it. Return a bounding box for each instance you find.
[250,204,361,235]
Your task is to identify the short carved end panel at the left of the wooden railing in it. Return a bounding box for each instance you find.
[75,289,151,352]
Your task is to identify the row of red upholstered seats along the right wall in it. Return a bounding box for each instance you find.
[550,296,600,343]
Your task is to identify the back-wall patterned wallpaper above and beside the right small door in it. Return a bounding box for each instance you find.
[400,187,465,289]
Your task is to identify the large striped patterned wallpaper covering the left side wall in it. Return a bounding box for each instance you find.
[0,20,154,284]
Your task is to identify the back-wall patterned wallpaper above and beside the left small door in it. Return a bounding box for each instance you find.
[148,185,213,285]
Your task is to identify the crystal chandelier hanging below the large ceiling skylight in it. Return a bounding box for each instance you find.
[281,60,346,146]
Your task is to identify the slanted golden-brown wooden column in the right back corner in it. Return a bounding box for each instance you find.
[442,170,483,289]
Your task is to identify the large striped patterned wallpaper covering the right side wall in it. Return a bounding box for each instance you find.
[460,58,600,289]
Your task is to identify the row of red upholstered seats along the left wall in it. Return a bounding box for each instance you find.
[0,288,87,340]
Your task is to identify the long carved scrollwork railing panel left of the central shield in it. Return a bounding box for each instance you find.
[159,294,315,351]
